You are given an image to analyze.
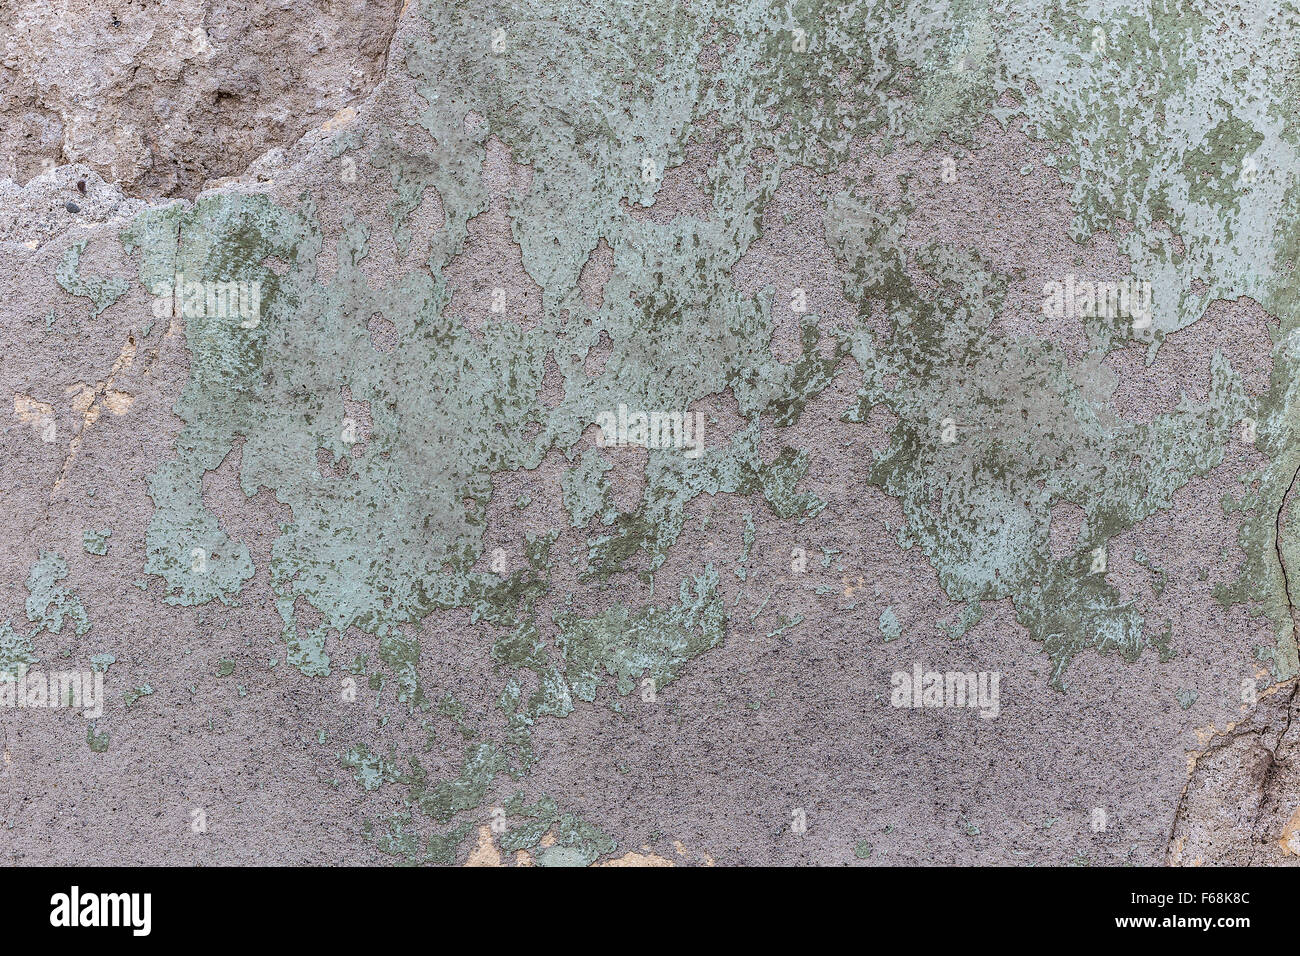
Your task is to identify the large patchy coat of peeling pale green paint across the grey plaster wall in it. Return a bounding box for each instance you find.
[65,0,1300,865]
